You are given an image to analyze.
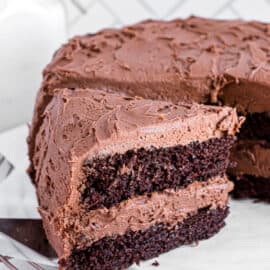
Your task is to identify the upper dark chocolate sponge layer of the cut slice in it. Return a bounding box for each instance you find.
[81,136,234,210]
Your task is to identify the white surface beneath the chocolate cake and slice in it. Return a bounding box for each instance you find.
[0,125,270,270]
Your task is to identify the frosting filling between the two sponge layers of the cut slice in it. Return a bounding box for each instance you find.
[69,176,233,249]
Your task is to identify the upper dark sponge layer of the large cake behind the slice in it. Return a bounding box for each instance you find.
[238,111,270,141]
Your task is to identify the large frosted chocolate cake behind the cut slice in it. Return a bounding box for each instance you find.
[29,17,270,201]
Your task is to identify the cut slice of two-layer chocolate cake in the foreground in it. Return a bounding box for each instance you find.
[32,89,241,270]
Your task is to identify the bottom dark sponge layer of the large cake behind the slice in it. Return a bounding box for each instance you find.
[230,174,270,202]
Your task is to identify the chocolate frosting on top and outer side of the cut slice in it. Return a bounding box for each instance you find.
[33,89,242,258]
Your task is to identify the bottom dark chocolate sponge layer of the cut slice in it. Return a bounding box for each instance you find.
[60,208,228,270]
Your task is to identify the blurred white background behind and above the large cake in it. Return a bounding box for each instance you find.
[0,0,270,131]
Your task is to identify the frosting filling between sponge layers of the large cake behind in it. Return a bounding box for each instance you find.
[229,140,270,178]
